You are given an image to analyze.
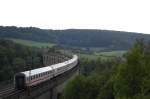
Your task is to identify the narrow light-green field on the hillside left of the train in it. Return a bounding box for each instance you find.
[9,38,55,48]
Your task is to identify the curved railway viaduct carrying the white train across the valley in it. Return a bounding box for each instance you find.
[0,53,79,99]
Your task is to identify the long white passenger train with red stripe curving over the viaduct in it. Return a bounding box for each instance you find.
[14,55,78,90]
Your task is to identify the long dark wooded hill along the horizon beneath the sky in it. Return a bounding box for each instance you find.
[0,26,150,50]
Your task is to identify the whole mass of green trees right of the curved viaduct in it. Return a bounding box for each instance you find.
[62,40,150,99]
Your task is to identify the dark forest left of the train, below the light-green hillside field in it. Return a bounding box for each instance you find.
[0,39,43,82]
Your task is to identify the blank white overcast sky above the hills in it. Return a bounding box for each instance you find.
[0,0,150,34]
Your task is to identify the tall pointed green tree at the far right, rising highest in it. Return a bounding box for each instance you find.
[114,40,150,99]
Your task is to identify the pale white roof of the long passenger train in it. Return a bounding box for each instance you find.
[21,55,78,77]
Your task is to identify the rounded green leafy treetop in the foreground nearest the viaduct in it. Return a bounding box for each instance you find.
[64,74,111,99]
